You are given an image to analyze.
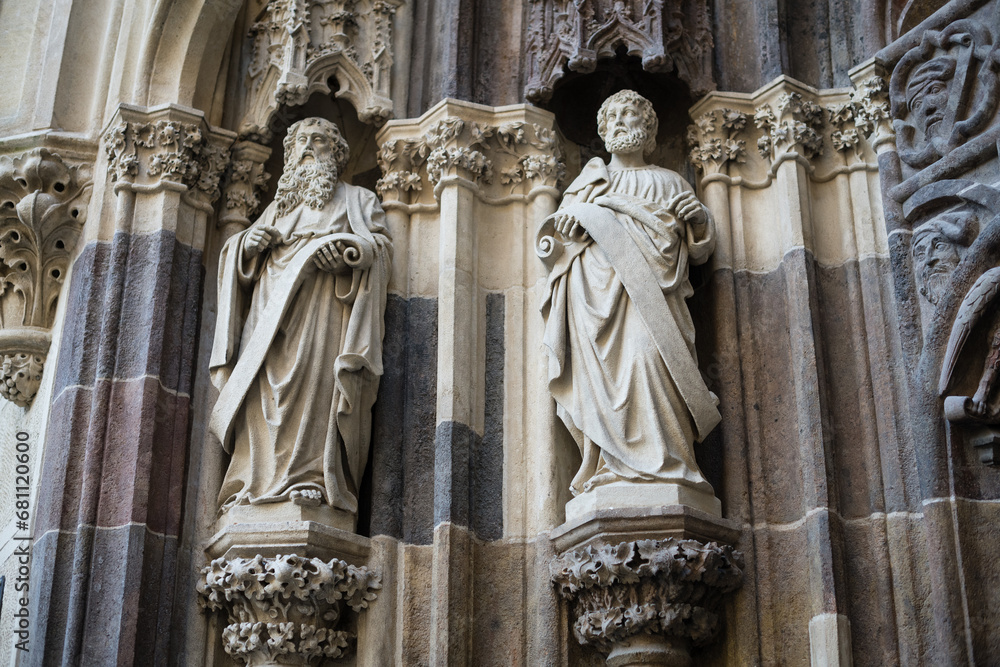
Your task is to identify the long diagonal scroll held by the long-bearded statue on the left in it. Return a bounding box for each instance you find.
[209,232,374,451]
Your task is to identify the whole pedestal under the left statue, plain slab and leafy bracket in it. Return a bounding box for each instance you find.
[198,516,381,667]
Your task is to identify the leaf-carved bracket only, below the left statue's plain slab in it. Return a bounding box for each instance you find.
[198,555,381,667]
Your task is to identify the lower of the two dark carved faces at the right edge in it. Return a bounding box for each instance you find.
[913,211,976,305]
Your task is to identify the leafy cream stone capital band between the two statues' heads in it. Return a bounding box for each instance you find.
[376,100,566,209]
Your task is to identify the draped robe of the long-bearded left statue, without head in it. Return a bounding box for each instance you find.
[210,183,392,512]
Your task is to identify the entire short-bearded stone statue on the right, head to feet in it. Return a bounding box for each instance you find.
[538,90,721,514]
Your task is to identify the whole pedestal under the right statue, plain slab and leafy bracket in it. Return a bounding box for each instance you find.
[549,498,744,667]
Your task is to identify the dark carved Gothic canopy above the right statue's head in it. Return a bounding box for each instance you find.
[524,0,715,103]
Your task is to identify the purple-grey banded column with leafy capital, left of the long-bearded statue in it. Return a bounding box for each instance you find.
[28,105,235,665]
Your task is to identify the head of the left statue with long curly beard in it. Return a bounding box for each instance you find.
[274,118,350,216]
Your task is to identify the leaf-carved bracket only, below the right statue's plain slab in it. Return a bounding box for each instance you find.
[550,538,745,666]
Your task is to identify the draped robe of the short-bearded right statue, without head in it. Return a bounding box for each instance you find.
[542,158,721,494]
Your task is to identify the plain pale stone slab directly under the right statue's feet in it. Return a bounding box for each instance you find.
[566,482,722,523]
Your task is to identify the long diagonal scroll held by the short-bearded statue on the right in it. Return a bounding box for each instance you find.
[559,197,720,436]
